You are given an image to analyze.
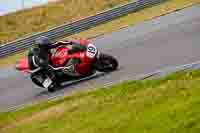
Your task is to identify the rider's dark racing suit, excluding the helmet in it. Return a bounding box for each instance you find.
[28,41,87,85]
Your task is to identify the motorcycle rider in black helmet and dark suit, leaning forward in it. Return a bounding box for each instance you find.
[28,36,87,87]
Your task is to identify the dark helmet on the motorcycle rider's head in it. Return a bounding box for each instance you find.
[35,36,52,48]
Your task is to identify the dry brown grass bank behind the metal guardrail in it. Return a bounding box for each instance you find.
[0,0,129,43]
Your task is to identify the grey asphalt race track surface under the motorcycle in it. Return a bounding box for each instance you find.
[0,5,200,111]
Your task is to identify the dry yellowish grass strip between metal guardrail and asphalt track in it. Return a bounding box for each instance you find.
[0,0,200,67]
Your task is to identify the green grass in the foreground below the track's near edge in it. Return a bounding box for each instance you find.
[0,71,200,133]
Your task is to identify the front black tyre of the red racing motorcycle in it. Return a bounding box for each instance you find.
[95,54,119,72]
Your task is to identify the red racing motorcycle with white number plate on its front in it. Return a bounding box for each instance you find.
[16,40,118,92]
